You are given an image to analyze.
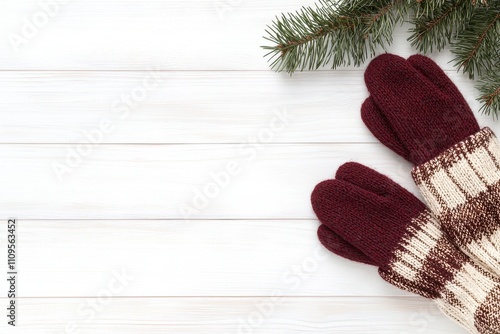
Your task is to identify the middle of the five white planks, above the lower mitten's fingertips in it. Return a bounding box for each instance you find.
[0,141,416,219]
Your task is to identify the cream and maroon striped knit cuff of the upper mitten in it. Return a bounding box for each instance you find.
[412,128,500,275]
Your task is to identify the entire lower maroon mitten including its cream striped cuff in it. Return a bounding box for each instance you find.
[311,163,500,333]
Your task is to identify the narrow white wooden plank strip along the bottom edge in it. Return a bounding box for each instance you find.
[0,297,466,334]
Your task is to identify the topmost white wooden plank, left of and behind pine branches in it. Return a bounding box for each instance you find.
[0,0,464,70]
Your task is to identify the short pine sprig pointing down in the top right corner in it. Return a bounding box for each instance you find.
[452,5,500,79]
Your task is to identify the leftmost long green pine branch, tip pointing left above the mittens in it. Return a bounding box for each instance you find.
[263,0,406,73]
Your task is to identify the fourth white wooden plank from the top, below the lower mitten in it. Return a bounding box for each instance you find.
[0,219,409,297]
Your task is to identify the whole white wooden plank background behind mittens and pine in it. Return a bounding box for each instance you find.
[0,0,500,334]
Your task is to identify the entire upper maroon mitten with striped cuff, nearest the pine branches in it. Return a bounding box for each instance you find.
[362,54,500,275]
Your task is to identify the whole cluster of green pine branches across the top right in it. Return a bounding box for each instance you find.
[263,0,500,115]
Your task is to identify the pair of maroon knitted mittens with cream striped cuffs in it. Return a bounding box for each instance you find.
[312,54,500,333]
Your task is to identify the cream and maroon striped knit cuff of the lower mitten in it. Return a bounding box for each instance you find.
[380,212,500,333]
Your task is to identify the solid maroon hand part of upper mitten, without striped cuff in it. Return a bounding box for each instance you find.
[362,54,479,165]
